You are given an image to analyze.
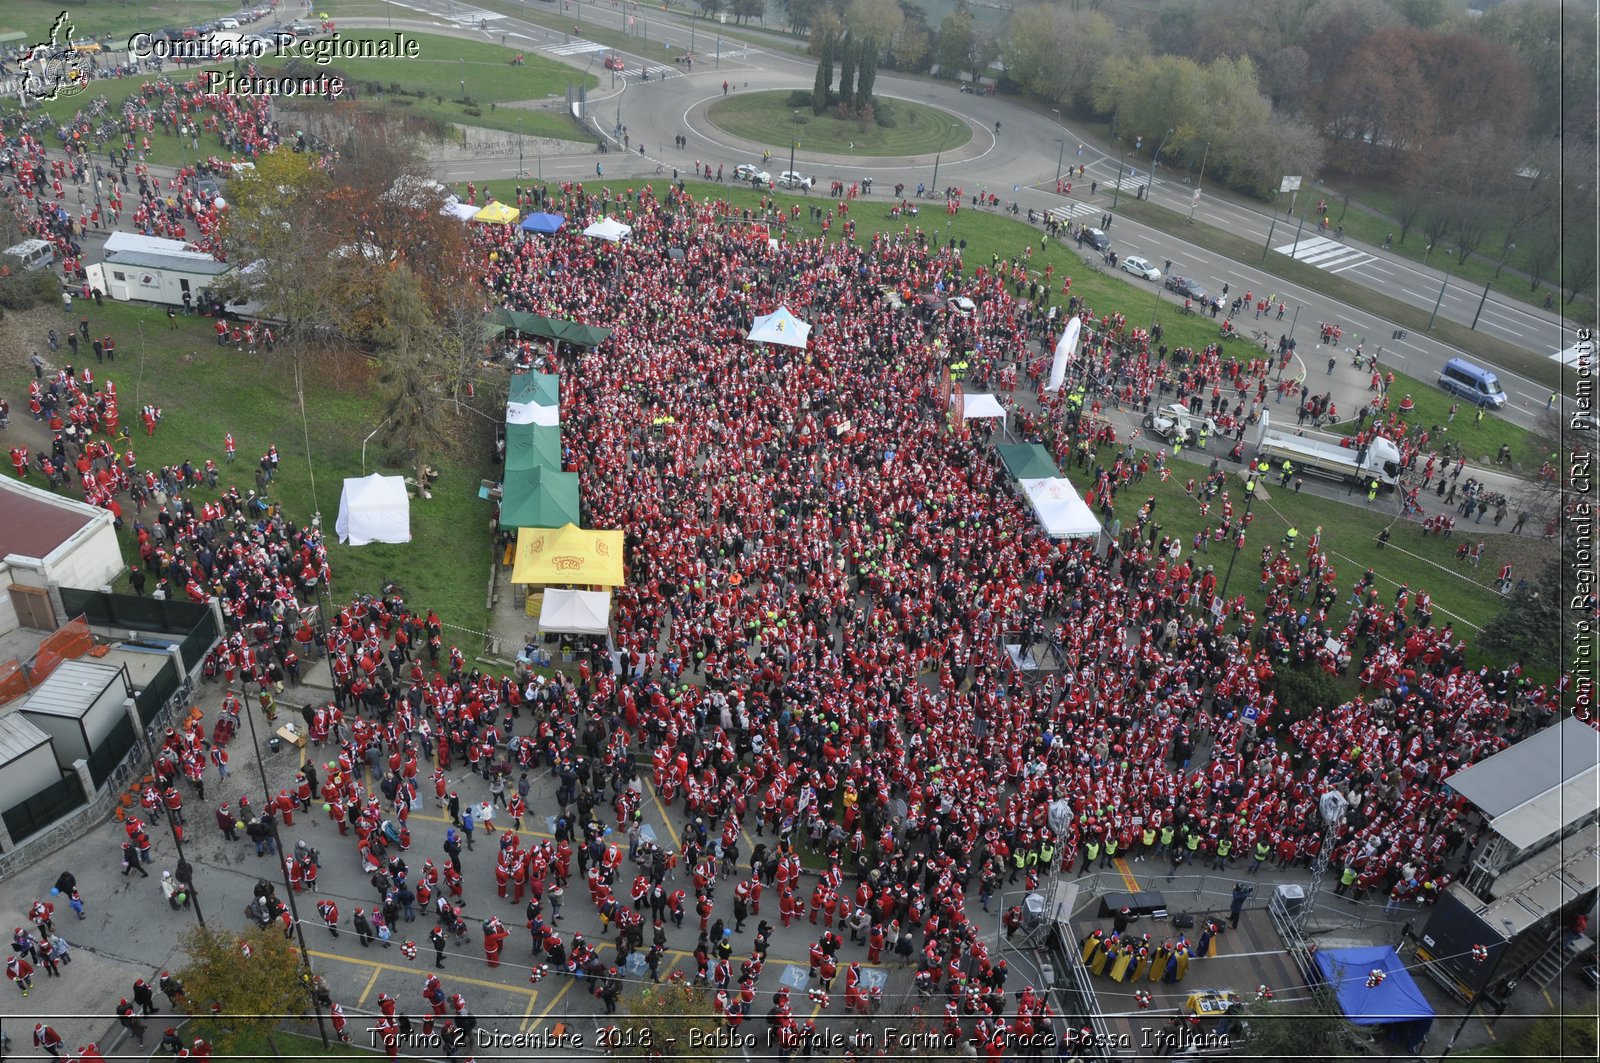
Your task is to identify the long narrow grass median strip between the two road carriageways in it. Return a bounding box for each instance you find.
[1117,195,1578,394]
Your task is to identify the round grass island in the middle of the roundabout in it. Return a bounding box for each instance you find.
[706,91,973,165]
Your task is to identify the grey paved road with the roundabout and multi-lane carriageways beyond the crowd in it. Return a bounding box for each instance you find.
[363,0,1574,427]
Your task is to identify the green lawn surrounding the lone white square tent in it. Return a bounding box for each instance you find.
[21,299,498,633]
